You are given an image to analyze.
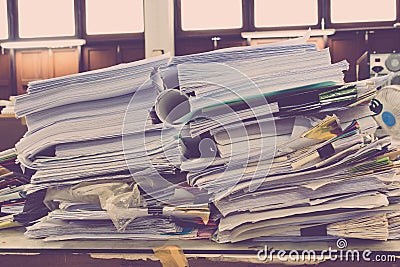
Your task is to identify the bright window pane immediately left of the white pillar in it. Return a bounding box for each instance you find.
[86,0,144,35]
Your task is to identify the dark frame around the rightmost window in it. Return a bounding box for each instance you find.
[326,0,400,29]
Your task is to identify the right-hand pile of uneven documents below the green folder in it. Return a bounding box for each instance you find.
[178,78,400,243]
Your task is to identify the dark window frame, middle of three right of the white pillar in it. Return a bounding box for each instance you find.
[249,0,324,31]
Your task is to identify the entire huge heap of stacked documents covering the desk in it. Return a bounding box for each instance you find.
[10,35,400,243]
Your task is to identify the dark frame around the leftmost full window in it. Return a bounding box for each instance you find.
[9,0,80,41]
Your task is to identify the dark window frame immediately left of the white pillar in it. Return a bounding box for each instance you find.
[80,0,145,42]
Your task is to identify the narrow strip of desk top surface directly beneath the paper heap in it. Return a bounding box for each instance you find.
[0,228,400,255]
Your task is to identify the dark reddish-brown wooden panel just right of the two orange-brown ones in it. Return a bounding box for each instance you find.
[83,45,118,71]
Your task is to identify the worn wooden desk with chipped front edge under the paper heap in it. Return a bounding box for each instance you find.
[0,228,400,267]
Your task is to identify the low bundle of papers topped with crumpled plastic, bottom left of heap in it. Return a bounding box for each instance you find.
[25,181,216,241]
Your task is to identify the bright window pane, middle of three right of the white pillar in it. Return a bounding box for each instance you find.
[254,0,318,27]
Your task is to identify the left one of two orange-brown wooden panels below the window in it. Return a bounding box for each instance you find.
[15,49,49,94]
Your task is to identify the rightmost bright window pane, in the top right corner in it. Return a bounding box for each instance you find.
[331,0,396,23]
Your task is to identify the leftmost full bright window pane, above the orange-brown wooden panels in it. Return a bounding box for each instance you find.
[18,0,75,38]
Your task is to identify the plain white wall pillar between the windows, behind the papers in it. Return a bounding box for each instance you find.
[143,0,175,58]
